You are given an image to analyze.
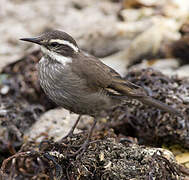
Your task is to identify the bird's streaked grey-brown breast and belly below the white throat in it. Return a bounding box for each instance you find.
[39,61,110,115]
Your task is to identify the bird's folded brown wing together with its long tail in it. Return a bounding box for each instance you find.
[73,53,182,116]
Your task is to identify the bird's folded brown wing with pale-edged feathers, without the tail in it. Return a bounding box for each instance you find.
[74,53,145,96]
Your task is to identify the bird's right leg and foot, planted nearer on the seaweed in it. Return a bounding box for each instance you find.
[68,118,97,157]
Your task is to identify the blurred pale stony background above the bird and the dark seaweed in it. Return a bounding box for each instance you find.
[0,0,189,76]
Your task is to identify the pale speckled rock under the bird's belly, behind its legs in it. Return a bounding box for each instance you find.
[24,108,78,142]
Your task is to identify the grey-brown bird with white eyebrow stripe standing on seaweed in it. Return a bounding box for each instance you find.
[20,30,181,155]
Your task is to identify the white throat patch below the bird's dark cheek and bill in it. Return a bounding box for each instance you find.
[41,46,72,66]
